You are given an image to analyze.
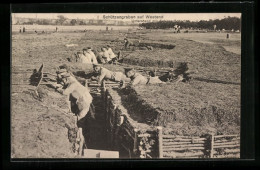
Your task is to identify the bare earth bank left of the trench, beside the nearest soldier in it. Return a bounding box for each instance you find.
[11,86,77,158]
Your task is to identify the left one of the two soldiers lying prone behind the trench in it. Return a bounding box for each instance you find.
[93,64,130,84]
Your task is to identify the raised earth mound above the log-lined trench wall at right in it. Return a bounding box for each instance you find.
[115,82,240,136]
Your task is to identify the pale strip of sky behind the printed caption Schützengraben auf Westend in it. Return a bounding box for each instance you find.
[12,13,241,21]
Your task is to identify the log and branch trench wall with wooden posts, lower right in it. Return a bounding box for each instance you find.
[103,87,240,159]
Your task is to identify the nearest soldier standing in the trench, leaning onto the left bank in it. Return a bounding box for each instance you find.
[59,73,93,155]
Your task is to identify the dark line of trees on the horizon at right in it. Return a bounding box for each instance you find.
[139,17,241,31]
